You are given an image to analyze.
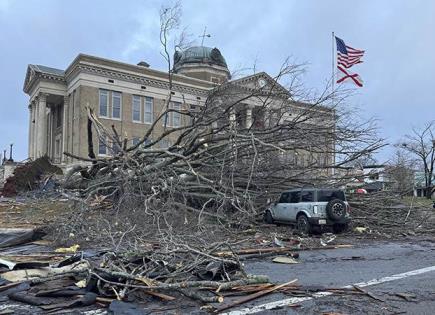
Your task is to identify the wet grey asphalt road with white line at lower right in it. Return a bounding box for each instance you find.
[226,239,435,315]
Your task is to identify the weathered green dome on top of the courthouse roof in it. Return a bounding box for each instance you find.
[174,46,230,83]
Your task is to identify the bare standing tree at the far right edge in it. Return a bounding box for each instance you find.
[397,120,435,198]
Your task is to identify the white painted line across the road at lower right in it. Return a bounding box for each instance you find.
[222,266,435,315]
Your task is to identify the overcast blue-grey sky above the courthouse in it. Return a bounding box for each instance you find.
[0,0,435,160]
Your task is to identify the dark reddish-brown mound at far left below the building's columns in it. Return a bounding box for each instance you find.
[2,156,62,197]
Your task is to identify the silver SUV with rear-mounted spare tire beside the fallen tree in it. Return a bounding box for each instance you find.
[264,188,350,234]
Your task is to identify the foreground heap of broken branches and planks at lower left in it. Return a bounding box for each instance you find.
[0,237,294,312]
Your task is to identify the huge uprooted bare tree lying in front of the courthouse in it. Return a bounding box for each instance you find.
[55,3,383,249]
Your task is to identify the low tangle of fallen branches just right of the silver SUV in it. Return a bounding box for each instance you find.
[348,191,435,235]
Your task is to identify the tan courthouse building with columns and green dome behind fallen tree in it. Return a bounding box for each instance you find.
[24,46,334,168]
